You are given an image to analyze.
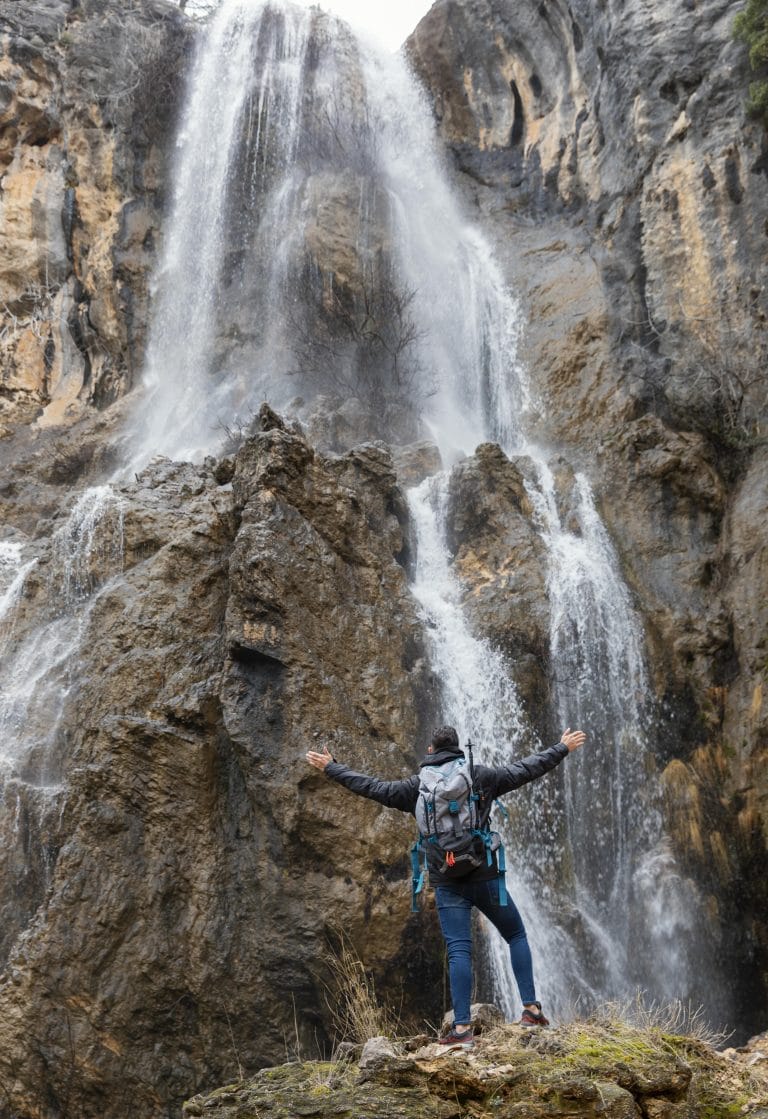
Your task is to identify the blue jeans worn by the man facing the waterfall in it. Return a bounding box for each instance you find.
[434,878,536,1025]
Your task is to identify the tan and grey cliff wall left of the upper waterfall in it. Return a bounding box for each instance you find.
[0,0,187,426]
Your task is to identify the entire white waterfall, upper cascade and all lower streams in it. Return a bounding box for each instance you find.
[0,0,729,1029]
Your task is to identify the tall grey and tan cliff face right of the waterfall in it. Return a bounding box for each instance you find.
[408,0,768,1026]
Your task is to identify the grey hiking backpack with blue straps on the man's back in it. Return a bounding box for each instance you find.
[411,743,507,911]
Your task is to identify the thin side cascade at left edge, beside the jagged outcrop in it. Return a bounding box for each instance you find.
[0,486,123,961]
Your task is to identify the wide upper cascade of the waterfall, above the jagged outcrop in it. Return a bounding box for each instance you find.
[127,0,525,470]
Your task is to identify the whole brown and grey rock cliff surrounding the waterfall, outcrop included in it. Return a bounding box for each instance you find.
[0,0,768,1119]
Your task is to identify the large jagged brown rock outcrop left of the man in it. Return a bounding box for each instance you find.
[0,412,439,1119]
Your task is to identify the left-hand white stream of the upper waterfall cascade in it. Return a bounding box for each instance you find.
[131,0,339,469]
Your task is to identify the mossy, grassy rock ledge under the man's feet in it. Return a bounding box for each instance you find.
[184,1017,768,1119]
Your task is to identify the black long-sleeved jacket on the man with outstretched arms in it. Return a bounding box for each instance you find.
[325,742,568,881]
